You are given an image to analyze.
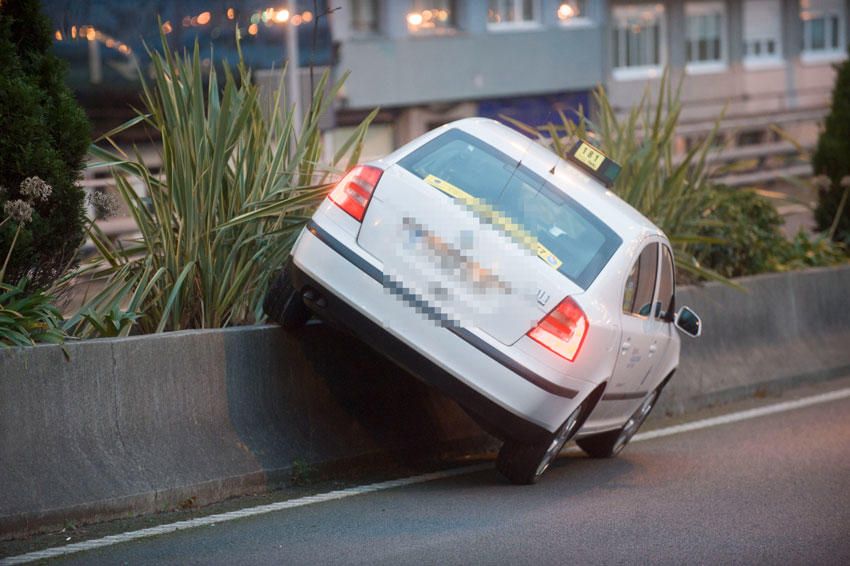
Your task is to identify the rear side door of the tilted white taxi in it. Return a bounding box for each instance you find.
[605,241,665,400]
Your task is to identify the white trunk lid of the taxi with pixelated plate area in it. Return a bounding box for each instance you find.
[358,165,582,345]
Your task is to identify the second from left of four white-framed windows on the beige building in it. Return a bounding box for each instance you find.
[685,2,726,70]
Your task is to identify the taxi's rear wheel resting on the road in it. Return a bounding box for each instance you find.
[496,402,586,485]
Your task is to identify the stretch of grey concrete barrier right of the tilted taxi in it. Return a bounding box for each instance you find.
[657,266,850,414]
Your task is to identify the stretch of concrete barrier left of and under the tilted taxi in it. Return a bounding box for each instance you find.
[0,325,490,536]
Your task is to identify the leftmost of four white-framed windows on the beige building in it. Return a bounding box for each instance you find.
[611,4,666,78]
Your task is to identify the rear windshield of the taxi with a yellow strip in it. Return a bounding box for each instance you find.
[399,129,622,289]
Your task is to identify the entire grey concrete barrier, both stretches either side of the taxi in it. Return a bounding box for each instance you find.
[0,266,850,537]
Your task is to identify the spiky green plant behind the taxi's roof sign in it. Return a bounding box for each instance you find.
[503,72,731,283]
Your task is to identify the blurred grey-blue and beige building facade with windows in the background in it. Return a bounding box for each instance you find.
[331,0,850,153]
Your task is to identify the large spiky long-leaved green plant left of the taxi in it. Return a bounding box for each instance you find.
[69,34,374,336]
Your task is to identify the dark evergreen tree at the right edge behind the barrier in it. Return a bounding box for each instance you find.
[812,53,850,244]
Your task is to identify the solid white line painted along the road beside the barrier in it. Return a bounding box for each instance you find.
[0,388,850,566]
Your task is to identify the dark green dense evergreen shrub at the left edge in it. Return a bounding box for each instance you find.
[0,0,89,289]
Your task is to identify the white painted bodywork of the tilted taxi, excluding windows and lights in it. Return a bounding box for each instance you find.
[284,119,679,436]
